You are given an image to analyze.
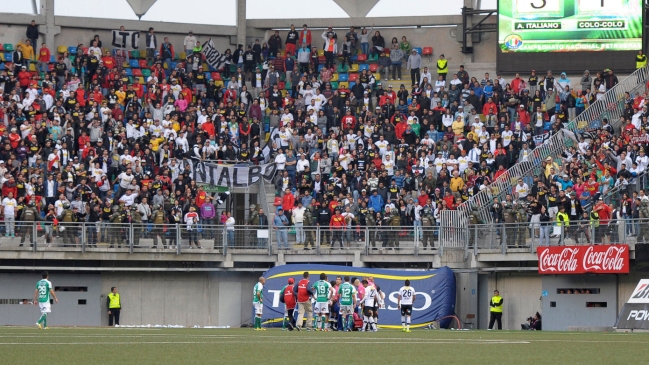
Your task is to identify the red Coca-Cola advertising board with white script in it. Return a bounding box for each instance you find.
[536,245,629,275]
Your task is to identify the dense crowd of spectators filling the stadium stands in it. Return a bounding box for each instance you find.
[0,20,649,247]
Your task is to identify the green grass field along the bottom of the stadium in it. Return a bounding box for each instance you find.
[0,327,649,365]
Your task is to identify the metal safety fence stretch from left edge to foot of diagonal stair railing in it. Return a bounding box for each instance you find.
[0,222,440,255]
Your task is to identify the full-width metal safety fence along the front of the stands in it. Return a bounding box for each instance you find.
[0,216,649,257]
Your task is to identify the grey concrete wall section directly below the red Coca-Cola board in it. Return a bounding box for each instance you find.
[542,275,618,331]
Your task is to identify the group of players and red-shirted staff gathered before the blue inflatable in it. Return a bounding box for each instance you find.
[253,272,416,332]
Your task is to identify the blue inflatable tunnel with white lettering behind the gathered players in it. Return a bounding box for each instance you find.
[253,264,455,328]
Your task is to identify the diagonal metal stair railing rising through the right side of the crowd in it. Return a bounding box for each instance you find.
[440,67,649,247]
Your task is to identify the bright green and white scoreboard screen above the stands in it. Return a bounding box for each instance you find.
[498,0,644,53]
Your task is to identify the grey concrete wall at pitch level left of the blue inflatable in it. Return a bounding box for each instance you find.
[0,272,258,327]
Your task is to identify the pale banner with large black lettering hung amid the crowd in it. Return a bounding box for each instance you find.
[192,162,276,188]
